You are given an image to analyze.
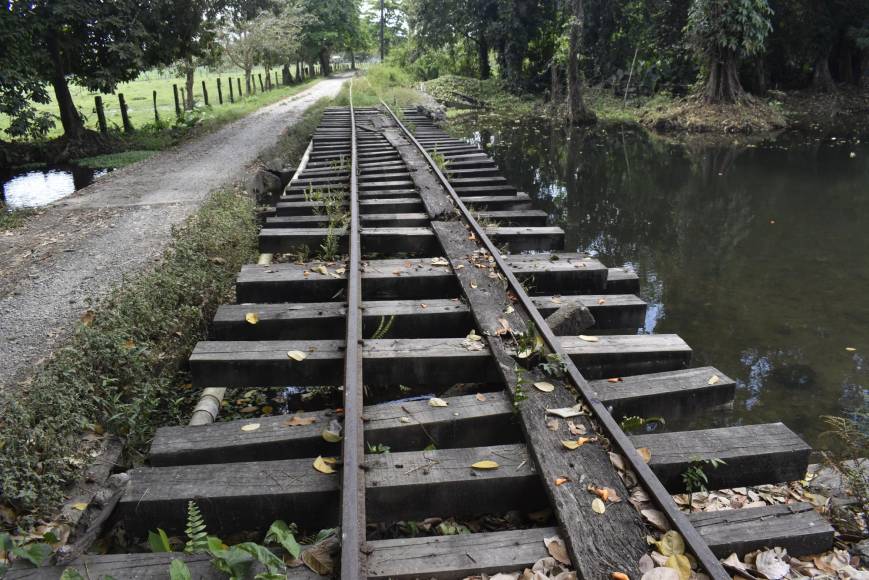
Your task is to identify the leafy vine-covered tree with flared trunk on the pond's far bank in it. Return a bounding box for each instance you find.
[687,0,772,103]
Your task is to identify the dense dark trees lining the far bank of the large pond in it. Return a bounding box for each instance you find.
[393,0,869,107]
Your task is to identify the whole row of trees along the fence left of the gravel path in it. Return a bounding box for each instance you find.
[0,0,371,140]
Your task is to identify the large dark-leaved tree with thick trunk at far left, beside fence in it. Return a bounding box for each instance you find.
[0,0,172,139]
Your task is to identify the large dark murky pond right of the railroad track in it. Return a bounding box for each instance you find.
[451,113,869,447]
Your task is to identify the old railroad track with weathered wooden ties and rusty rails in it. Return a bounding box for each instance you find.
[17,84,833,579]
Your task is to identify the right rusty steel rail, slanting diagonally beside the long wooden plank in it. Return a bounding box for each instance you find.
[380,99,730,580]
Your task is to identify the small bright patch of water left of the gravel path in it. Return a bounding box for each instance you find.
[0,165,110,209]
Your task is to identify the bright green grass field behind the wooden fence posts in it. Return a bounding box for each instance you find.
[0,68,318,139]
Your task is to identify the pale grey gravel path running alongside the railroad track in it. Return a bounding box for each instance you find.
[0,77,344,390]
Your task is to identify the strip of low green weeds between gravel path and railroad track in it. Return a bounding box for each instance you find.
[0,190,256,527]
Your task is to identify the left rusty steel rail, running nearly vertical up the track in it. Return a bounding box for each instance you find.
[341,79,367,580]
